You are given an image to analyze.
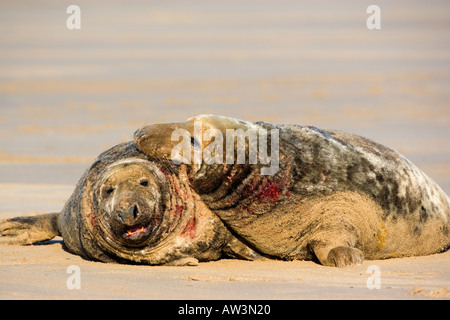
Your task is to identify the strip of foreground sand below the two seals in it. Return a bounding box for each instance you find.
[0,241,450,300]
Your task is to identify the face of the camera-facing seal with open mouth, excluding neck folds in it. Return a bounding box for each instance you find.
[93,159,168,246]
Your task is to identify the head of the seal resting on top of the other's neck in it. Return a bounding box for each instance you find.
[134,115,278,195]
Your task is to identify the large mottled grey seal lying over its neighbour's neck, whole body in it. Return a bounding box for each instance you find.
[134,115,450,266]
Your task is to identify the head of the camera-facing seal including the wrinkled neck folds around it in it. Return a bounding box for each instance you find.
[82,157,193,262]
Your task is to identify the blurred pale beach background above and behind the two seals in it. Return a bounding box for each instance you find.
[0,0,450,218]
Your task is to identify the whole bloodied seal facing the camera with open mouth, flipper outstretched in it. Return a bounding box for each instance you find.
[0,142,239,265]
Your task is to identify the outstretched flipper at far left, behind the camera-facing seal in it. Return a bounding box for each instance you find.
[0,212,61,245]
